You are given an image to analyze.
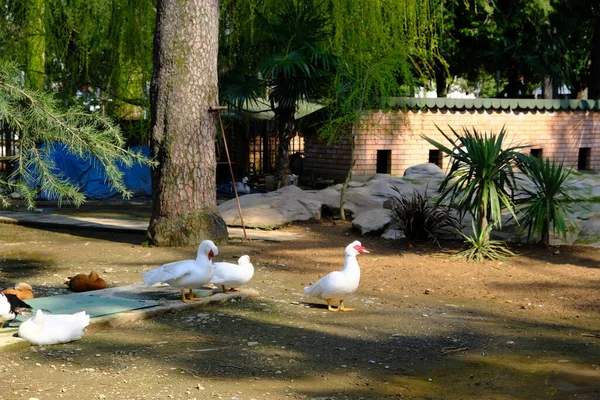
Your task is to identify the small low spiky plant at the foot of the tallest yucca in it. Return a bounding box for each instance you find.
[453,221,515,262]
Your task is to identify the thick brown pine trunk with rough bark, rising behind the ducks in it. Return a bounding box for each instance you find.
[148,0,227,246]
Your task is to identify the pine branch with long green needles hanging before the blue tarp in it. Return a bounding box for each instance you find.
[0,63,153,208]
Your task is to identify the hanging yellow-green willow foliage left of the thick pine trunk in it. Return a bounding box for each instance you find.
[0,0,156,131]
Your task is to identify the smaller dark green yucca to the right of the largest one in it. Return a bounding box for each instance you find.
[518,156,573,246]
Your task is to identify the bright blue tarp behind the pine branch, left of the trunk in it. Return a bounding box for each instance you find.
[33,144,152,200]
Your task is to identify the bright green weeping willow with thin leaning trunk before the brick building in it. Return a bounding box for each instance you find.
[321,0,441,218]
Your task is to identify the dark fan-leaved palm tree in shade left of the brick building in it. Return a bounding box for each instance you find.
[221,0,339,186]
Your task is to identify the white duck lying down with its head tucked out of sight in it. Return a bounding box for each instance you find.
[18,310,90,346]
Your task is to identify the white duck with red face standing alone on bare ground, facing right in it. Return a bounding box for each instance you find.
[304,240,368,311]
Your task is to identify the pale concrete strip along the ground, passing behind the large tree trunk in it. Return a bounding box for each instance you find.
[0,211,302,242]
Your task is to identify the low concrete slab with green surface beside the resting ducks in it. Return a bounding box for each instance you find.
[0,283,259,350]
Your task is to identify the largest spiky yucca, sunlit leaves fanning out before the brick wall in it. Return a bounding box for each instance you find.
[423,127,525,260]
